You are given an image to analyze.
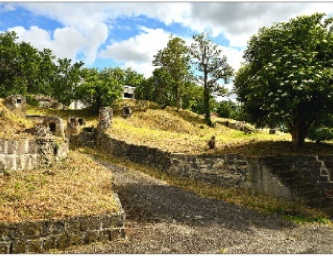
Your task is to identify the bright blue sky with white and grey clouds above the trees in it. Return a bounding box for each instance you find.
[0,0,333,92]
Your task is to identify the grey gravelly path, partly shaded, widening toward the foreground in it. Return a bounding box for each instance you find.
[61,159,333,254]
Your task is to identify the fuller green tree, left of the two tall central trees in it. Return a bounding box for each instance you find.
[153,36,191,109]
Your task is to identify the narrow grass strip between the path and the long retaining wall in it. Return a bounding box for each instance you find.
[80,148,333,224]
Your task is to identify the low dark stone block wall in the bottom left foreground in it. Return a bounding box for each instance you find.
[0,210,125,254]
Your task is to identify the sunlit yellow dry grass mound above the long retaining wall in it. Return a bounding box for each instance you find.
[107,104,290,154]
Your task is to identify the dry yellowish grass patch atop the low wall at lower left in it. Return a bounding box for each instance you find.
[0,152,119,222]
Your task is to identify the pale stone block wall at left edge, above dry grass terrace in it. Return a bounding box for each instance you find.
[0,138,68,174]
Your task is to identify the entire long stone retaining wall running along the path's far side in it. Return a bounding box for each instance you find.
[73,132,333,204]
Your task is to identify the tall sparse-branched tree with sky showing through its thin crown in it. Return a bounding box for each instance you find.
[190,33,233,125]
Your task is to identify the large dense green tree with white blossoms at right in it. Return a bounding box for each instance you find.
[235,13,333,147]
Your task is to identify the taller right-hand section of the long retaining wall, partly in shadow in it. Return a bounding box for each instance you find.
[167,154,333,204]
